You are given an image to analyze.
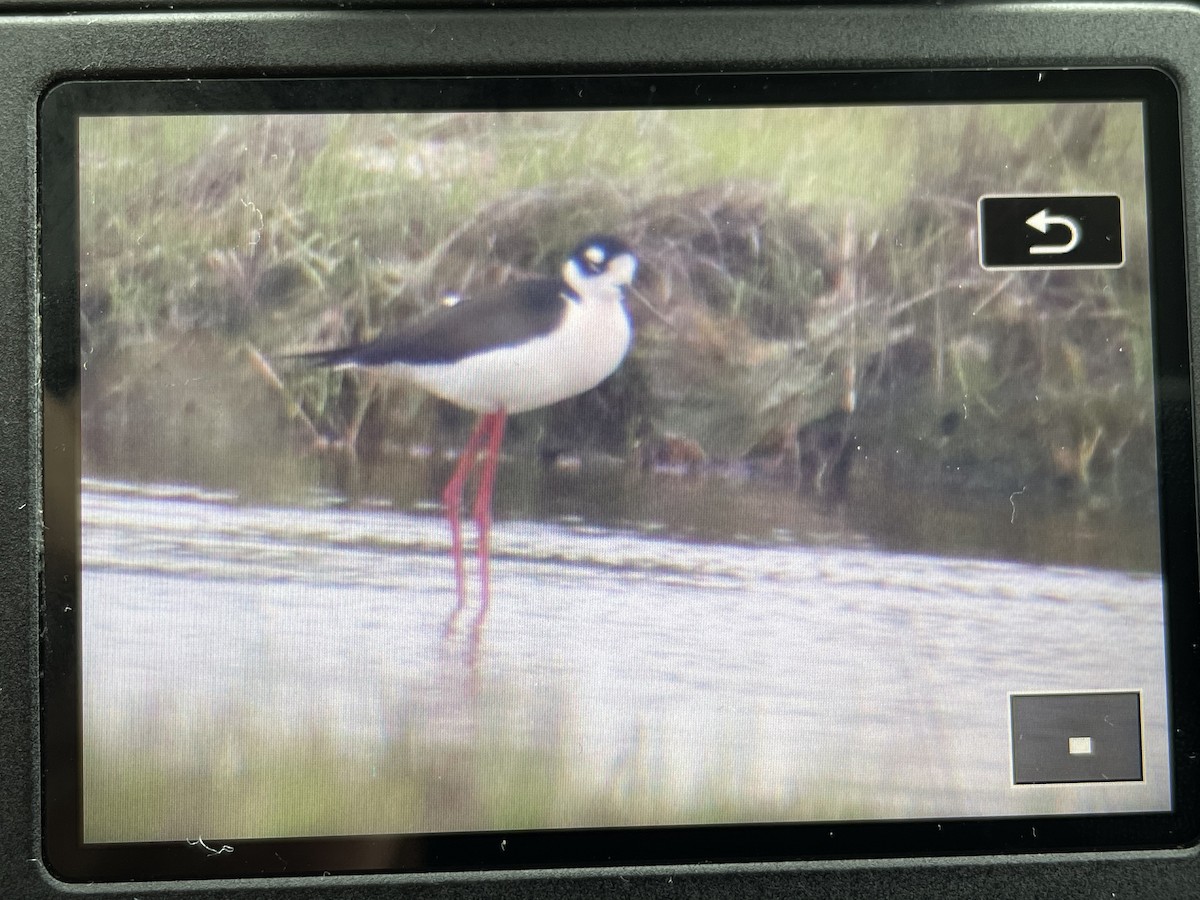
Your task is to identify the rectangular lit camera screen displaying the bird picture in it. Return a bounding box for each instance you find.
[43,74,1194,871]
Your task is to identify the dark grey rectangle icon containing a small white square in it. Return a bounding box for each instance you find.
[1009,691,1142,785]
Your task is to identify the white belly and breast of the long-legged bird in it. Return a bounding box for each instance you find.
[386,298,632,413]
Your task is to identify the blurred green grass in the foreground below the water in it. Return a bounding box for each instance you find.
[83,691,883,841]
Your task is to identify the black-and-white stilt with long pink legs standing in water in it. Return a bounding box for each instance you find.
[300,236,637,625]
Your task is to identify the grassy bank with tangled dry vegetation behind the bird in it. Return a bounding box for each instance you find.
[80,104,1156,505]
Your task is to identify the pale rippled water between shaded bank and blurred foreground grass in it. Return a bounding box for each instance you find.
[82,480,1169,844]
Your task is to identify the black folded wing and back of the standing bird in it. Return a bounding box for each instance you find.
[291,278,570,366]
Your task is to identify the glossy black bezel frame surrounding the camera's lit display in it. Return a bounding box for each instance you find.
[38,68,1200,881]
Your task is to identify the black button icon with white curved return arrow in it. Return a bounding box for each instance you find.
[979,194,1124,269]
